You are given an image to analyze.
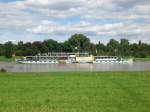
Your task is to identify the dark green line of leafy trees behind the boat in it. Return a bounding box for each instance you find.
[0,34,150,58]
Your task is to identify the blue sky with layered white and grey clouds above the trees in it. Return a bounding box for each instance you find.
[0,0,150,43]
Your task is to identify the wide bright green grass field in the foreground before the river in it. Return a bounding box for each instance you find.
[0,72,150,112]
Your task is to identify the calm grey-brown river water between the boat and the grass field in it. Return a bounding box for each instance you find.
[0,61,150,72]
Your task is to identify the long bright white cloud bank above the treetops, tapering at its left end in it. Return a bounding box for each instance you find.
[28,21,150,42]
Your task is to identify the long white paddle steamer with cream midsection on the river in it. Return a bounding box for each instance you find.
[17,52,133,64]
